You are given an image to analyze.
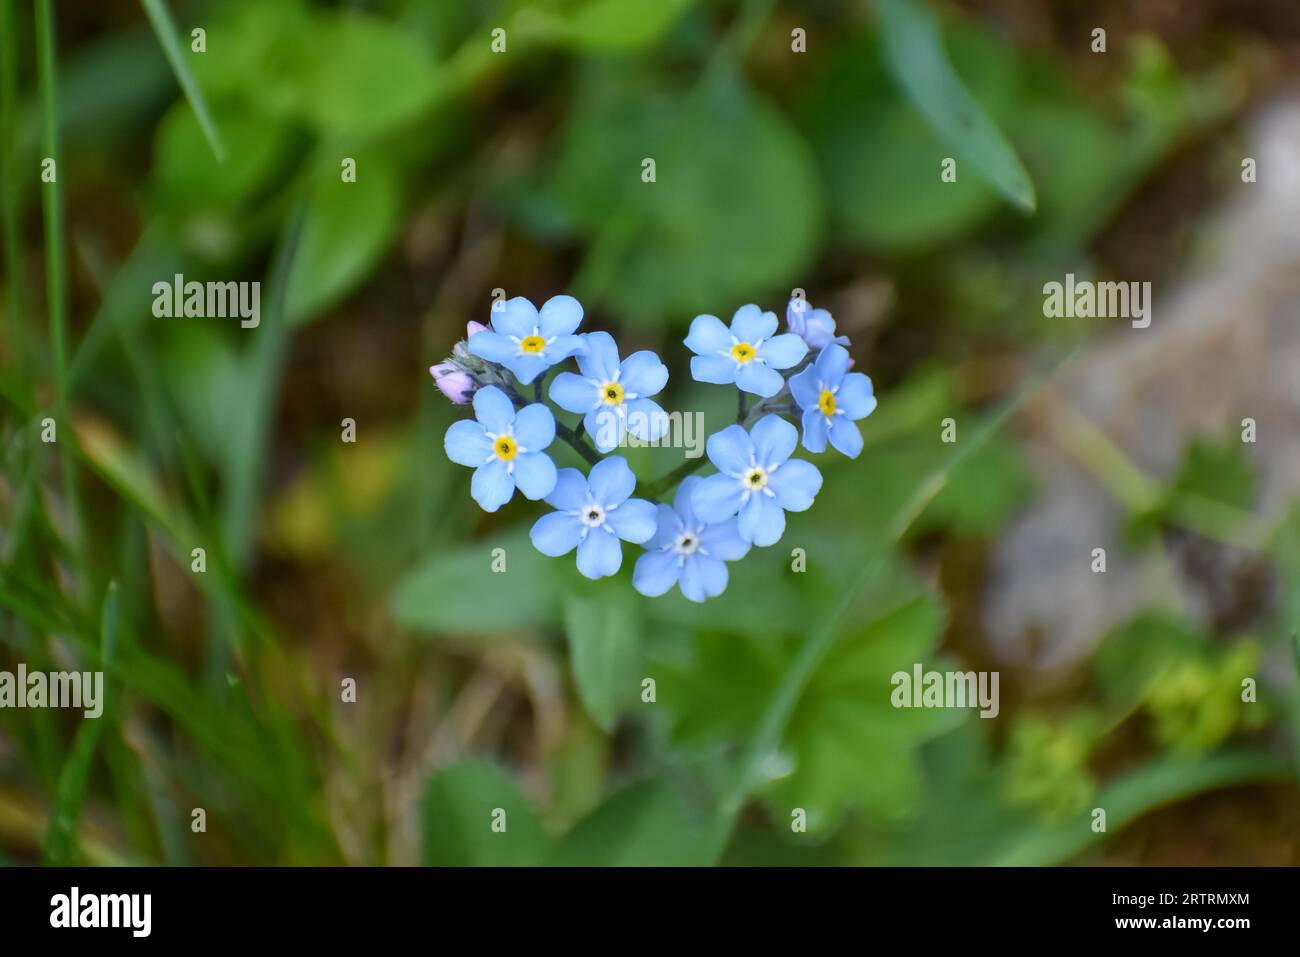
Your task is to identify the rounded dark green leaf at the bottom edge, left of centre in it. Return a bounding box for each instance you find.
[420,761,550,867]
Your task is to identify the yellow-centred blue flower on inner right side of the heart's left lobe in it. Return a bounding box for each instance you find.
[550,333,668,452]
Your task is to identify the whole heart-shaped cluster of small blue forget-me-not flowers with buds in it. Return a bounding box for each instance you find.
[429,295,876,602]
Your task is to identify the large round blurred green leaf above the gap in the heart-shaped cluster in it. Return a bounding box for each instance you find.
[543,68,822,322]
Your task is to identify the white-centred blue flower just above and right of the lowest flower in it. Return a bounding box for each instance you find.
[690,415,822,546]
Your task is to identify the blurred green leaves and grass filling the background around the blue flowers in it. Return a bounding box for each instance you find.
[0,0,1300,865]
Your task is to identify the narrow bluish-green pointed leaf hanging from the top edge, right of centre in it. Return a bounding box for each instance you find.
[876,0,1036,212]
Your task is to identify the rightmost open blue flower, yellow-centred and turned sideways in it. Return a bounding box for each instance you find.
[790,343,876,459]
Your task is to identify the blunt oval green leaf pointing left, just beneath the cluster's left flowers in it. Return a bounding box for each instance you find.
[390,529,564,635]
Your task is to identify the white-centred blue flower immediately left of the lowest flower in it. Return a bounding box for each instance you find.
[529,455,655,579]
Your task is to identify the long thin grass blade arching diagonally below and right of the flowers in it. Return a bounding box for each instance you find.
[711,352,1075,861]
